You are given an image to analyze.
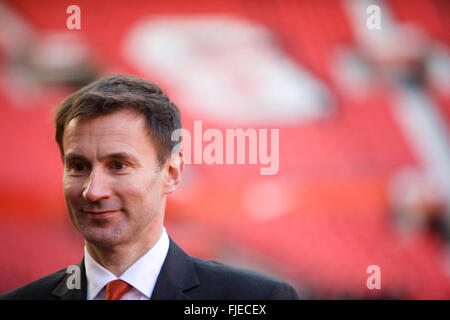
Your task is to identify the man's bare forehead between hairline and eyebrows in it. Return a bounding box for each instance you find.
[63,108,154,160]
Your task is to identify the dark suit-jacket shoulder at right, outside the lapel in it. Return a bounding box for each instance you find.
[191,257,298,300]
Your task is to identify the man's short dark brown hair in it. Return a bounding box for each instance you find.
[54,75,181,166]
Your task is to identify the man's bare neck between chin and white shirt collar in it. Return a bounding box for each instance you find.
[85,221,162,277]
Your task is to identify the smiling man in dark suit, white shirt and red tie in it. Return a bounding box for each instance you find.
[1,75,298,300]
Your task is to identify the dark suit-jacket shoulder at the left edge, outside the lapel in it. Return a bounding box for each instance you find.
[0,269,67,300]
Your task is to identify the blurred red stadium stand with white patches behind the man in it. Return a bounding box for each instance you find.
[0,0,450,299]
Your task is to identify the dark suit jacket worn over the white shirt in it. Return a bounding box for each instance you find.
[0,239,298,300]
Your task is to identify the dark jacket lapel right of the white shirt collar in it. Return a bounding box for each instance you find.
[151,239,200,300]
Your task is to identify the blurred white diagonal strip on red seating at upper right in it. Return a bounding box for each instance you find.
[339,0,450,207]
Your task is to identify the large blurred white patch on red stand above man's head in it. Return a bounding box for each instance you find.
[124,16,334,125]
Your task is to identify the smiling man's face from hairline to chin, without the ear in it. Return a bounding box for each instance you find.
[63,109,165,247]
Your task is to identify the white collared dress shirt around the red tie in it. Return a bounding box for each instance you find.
[84,227,169,300]
